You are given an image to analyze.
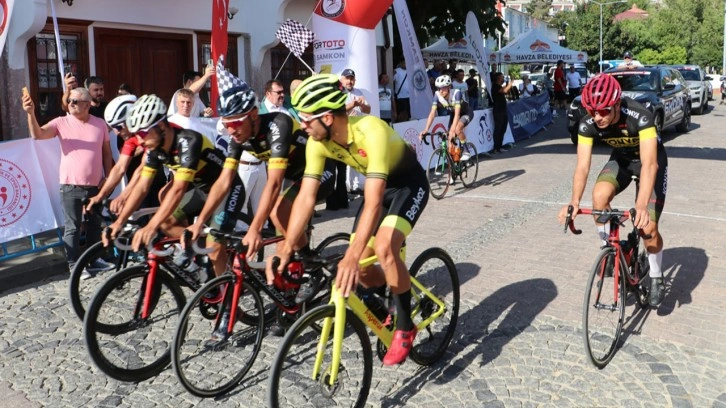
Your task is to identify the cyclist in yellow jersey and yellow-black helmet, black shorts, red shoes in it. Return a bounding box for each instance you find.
[267,74,429,365]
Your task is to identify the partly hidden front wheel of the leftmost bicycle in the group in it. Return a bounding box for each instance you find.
[68,242,139,322]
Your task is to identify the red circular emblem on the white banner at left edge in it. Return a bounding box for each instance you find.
[0,159,31,227]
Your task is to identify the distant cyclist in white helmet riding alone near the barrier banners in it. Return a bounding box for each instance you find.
[419,75,474,160]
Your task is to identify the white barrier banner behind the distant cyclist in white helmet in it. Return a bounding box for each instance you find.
[393,108,514,168]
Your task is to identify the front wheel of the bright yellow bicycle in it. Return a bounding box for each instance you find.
[267,305,373,408]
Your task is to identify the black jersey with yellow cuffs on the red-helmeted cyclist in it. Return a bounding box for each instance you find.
[577,97,661,159]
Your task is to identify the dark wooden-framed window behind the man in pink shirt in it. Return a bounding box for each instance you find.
[28,23,88,125]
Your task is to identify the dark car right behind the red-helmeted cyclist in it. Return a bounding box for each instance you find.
[567,65,691,144]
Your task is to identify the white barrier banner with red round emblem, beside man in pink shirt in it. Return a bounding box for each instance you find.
[0,139,59,243]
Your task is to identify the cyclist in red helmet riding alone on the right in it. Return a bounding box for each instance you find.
[559,74,668,306]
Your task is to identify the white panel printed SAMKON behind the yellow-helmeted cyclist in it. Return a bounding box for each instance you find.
[313,14,380,116]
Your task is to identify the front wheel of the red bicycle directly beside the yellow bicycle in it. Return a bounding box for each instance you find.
[171,274,264,397]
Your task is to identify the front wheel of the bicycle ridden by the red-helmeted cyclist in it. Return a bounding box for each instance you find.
[582,247,625,368]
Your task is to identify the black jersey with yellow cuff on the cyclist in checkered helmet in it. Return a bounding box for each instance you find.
[242,112,308,180]
